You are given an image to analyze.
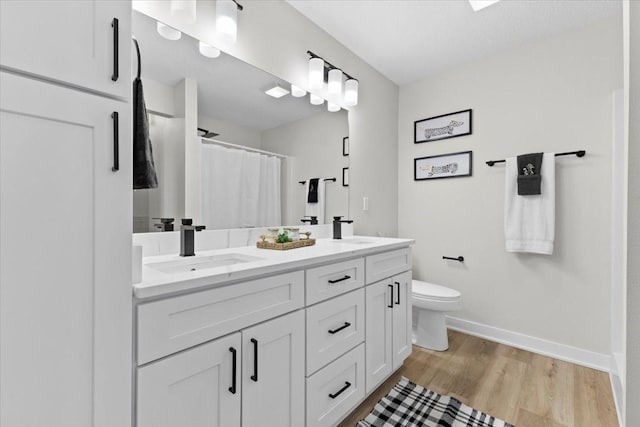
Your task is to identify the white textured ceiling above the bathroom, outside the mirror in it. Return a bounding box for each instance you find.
[287,0,622,85]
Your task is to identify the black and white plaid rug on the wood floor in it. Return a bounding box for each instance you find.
[358,377,513,427]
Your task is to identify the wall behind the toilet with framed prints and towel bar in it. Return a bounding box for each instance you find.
[399,21,622,362]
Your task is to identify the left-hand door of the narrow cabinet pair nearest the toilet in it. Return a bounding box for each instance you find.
[365,279,394,393]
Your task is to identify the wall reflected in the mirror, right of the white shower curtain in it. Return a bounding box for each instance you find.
[262,111,349,224]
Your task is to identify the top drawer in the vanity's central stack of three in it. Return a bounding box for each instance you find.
[307,258,364,305]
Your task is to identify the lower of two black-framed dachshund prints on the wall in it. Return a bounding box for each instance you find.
[413,151,473,181]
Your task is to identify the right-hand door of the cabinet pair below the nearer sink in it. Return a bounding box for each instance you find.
[242,310,305,427]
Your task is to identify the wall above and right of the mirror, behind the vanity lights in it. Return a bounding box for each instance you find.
[133,0,398,236]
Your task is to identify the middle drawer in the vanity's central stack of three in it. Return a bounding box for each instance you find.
[307,289,364,375]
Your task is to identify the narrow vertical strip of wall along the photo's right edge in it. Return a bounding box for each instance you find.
[624,1,640,427]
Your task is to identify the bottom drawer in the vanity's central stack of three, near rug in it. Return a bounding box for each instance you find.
[307,344,364,427]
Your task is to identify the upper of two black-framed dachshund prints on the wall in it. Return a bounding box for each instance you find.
[413,109,472,144]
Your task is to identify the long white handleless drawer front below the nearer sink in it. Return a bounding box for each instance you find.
[138,271,304,365]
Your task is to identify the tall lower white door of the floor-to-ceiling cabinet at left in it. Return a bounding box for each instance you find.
[0,72,132,427]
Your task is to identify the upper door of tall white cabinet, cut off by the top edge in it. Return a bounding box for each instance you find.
[0,0,131,98]
